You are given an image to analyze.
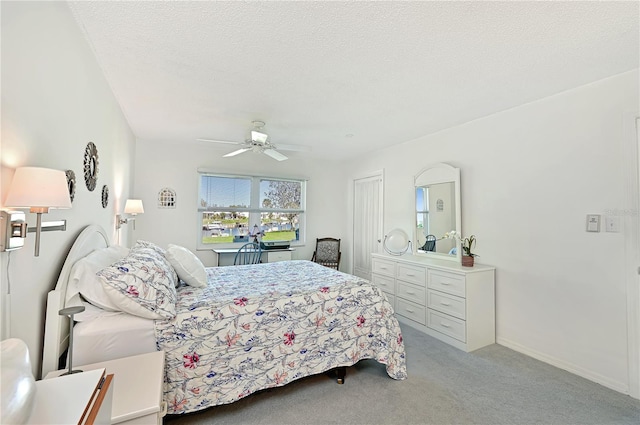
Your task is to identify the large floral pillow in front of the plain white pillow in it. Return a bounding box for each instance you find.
[98,243,178,319]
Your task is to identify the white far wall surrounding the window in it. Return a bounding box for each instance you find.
[134,140,350,264]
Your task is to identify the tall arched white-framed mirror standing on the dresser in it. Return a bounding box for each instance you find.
[414,163,462,262]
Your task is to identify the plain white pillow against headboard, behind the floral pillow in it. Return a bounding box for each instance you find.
[67,245,129,311]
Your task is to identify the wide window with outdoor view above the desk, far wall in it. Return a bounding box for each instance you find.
[198,172,306,248]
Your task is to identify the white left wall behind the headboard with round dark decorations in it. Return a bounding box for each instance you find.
[0,2,135,376]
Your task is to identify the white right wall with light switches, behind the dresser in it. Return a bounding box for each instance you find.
[345,70,639,392]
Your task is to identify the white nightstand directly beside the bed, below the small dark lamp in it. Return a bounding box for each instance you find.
[45,351,167,425]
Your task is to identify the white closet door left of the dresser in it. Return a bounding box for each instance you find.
[353,171,384,280]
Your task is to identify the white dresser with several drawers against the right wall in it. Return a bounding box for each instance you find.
[371,254,496,351]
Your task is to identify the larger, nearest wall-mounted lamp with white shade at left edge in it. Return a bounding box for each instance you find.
[5,167,71,257]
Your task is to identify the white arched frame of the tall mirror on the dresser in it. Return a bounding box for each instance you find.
[412,162,462,263]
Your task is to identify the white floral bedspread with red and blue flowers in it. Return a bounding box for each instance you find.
[155,260,407,414]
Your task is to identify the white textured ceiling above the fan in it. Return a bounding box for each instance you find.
[69,1,639,159]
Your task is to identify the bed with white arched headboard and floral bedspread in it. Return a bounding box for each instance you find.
[42,225,407,414]
